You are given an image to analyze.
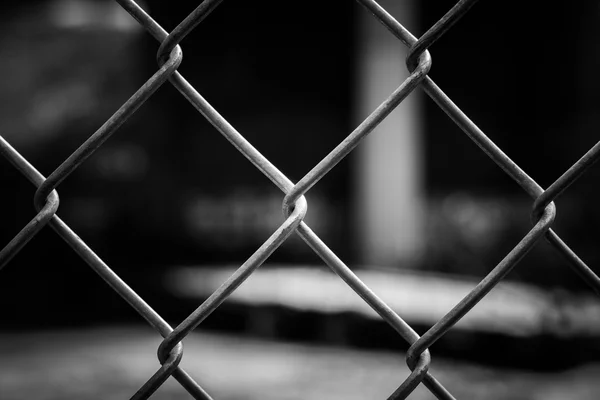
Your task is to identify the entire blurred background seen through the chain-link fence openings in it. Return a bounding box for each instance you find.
[0,0,600,399]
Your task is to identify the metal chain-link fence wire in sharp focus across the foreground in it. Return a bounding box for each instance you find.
[0,0,600,399]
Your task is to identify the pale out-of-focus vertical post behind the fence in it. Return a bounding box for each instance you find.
[354,0,425,267]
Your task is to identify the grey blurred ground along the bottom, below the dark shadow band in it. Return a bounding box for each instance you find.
[0,326,600,400]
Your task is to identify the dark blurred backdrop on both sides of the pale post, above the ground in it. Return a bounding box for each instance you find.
[0,0,600,372]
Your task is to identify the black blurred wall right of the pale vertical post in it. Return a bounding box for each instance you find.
[420,0,600,290]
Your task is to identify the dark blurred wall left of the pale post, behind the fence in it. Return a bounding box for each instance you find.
[0,0,354,321]
